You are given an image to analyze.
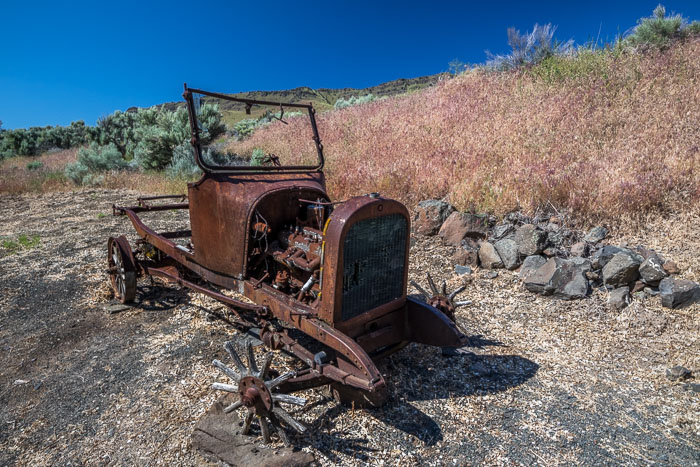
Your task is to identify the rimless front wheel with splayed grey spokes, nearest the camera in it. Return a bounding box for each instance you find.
[212,341,306,445]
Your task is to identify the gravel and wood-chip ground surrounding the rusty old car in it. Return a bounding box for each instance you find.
[0,190,700,465]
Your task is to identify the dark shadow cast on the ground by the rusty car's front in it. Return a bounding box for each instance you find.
[298,336,539,462]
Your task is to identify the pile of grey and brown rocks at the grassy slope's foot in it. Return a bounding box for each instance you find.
[414,200,700,309]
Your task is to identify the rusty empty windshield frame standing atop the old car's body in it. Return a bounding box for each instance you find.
[182,83,324,173]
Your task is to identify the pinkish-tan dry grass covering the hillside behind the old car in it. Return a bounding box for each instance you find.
[230,40,700,217]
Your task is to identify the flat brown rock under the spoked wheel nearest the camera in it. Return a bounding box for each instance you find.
[192,401,315,467]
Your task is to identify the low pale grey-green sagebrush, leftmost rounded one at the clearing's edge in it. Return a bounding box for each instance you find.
[64,143,129,185]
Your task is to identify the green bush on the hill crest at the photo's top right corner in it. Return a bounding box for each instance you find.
[625,5,700,49]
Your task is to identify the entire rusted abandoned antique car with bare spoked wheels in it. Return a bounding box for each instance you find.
[107,85,466,442]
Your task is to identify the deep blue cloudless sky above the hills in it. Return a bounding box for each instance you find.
[0,0,700,128]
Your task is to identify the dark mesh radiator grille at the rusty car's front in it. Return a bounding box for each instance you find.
[341,214,408,321]
